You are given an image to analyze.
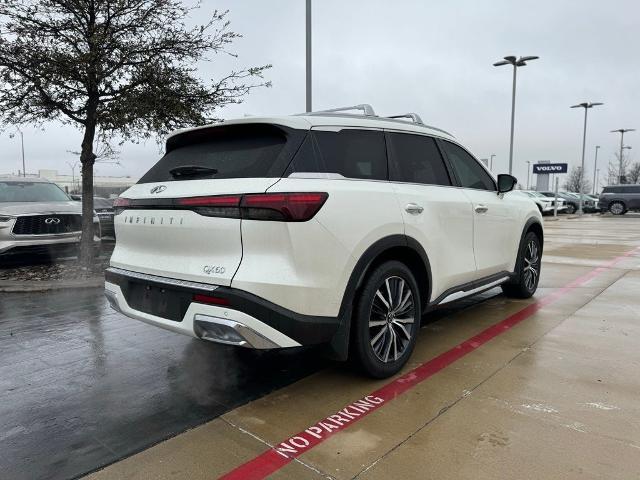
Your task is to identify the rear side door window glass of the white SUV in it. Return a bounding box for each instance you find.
[387,133,451,185]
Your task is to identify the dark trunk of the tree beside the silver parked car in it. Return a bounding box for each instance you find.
[80,120,97,267]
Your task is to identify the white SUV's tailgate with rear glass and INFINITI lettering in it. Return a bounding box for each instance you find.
[111,124,306,286]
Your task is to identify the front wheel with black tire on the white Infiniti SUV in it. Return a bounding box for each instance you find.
[502,232,542,298]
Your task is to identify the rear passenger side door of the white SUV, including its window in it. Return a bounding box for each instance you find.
[386,131,476,300]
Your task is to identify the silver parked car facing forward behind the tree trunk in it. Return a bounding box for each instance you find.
[0,176,100,258]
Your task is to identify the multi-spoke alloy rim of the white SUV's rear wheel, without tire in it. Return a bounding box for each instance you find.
[369,276,416,363]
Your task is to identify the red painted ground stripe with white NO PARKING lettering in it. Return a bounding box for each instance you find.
[220,247,640,480]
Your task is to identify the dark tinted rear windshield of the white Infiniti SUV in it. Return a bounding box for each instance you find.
[138,124,304,183]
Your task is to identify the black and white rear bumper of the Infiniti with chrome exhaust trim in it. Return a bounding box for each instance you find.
[105,268,339,348]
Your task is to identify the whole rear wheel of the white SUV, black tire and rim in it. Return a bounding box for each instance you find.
[351,261,422,378]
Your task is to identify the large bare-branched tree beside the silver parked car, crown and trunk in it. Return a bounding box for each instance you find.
[0,0,270,265]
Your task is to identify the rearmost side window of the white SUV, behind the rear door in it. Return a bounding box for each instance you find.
[285,129,388,180]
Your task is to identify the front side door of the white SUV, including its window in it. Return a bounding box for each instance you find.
[440,140,521,278]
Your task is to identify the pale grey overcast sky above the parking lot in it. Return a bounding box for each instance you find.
[0,0,640,188]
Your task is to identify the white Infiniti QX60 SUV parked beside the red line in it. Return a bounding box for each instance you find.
[105,105,543,377]
